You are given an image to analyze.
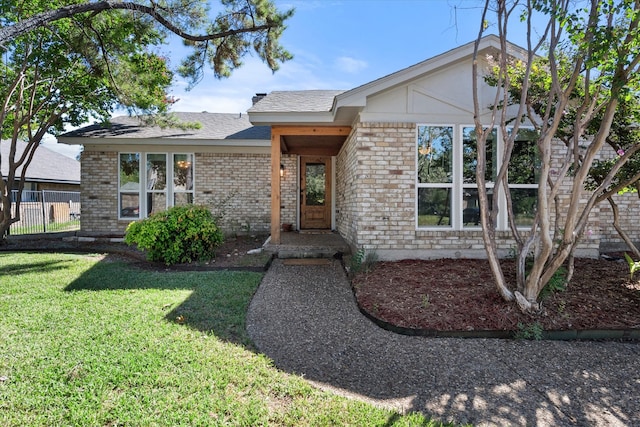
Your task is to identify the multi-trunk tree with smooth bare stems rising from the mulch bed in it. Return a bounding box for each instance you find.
[473,0,640,312]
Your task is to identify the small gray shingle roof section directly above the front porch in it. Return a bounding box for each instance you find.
[248,90,344,113]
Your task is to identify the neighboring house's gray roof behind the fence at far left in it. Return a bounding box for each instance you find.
[0,140,80,184]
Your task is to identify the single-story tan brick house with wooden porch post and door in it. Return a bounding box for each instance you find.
[60,36,640,259]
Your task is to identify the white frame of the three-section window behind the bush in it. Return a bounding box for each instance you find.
[117,151,196,221]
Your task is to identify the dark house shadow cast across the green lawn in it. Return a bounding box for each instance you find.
[65,255,262,350]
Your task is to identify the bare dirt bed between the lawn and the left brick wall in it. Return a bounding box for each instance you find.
[0,235,271,271]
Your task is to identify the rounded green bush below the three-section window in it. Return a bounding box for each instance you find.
[124,205,224,265]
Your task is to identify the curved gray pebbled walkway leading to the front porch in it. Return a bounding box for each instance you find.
[247,260,640,426]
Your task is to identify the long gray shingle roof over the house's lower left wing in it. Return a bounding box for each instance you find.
[60,112,271,142]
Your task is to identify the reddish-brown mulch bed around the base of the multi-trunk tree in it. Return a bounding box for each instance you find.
[353,259,640,331]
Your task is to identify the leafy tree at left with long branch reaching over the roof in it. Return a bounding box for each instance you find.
[0,0,293,240]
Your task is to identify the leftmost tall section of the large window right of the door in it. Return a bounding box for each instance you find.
[417,126,453,227]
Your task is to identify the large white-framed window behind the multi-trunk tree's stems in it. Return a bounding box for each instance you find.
[416,125,540,230]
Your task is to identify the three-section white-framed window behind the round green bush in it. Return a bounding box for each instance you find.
[118,153,194,219]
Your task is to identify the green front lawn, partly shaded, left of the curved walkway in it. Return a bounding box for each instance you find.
[0,253,439,426]
